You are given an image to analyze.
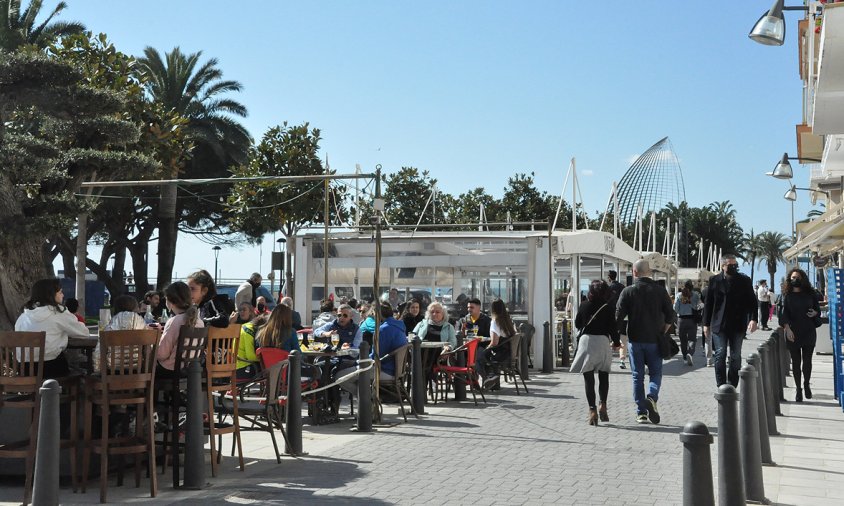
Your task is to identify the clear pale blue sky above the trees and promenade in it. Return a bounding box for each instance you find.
[54,0,811,286]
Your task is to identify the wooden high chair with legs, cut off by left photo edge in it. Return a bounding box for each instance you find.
[0,332,46,504]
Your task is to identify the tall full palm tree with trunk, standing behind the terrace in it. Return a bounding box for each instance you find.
[138,47,252,288]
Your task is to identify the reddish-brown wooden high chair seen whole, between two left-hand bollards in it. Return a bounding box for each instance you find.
[82,329,161,503]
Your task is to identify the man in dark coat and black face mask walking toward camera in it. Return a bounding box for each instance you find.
[703,254,758,387]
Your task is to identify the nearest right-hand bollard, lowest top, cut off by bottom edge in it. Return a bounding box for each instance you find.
[680,422,715,506]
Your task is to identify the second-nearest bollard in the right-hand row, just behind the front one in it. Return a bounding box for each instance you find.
[715,383,746,506]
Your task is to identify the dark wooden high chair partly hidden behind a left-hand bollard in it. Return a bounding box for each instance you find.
[156,325,208,488]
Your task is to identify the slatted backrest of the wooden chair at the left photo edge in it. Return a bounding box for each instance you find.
[0,331,47,408]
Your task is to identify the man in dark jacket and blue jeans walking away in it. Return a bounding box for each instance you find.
[615,260,676,423]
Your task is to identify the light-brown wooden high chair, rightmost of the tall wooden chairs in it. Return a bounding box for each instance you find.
[205,324,244,476]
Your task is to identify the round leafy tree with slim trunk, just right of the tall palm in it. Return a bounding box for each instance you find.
[227,122,343,293]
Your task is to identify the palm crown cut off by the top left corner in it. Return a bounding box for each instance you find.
[0,0,85,51]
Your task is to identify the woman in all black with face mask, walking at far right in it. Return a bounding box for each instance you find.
[779,267,821,402]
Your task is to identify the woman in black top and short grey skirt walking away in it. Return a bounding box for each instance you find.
[569,279,621,426]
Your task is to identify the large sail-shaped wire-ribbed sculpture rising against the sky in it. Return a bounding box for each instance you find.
[618,137,686,223]
